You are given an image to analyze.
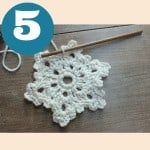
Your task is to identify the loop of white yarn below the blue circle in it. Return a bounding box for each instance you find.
[0,45,21,72]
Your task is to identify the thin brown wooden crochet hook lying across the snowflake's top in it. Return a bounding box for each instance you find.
[41,30,143,57]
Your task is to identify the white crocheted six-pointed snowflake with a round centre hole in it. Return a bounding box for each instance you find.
[24,40,111,127]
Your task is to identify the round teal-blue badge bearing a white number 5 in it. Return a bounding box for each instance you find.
[2,3,54,55]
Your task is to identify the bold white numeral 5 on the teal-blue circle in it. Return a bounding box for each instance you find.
[14,10,41,41]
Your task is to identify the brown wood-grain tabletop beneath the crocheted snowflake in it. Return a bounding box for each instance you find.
[0,25,150,132]
